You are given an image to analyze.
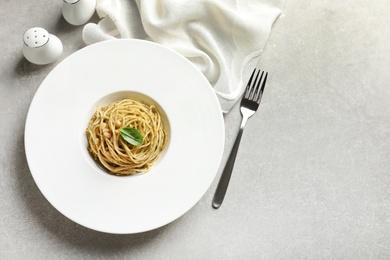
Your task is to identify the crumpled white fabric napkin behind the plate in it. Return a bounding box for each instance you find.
[83,0,285,112]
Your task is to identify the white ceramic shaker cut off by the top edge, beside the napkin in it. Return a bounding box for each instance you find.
[62,0,96,25]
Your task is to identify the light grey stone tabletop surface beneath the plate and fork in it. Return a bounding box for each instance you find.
[0,0,390,259]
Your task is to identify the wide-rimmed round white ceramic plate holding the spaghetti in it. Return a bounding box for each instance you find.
[25,40,224,234]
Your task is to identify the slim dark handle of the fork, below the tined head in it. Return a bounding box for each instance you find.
[212,117,248,209]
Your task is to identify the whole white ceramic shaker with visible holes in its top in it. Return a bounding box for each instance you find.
[23,27,63,65]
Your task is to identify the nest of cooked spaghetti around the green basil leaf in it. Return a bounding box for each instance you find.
[86,98,167,175]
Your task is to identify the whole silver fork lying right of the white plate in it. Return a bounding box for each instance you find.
[213,69,268,209]
